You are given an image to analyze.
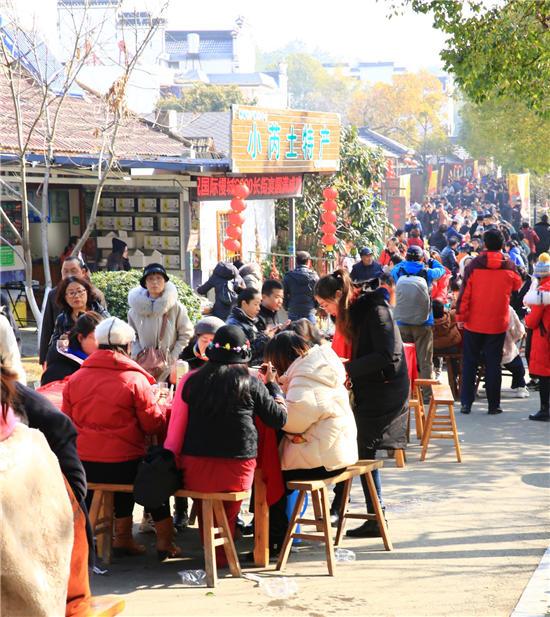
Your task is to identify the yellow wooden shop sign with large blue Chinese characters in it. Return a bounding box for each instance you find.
[231,105,340,173]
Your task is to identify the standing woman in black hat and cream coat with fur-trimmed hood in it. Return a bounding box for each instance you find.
[128,264,193,381]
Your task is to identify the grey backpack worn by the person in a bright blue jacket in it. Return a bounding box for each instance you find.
[393,269,432,326]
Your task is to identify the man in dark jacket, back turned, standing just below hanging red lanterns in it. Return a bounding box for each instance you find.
[283,251,319,324]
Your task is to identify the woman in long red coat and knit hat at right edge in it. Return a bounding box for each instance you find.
[524,253,550,422]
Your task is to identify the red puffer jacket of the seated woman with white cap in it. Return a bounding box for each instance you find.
[62,349,166,463]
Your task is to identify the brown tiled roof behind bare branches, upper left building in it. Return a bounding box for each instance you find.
[0,71,189,157]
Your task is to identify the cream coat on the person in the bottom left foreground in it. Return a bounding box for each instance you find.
[0,422,73,617]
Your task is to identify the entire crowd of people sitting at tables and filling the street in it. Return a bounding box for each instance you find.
[0,172,550,615]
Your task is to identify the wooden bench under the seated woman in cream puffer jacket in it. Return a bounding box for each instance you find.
[276,461,393,576]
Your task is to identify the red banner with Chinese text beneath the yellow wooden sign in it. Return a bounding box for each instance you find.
[197,174,303,201]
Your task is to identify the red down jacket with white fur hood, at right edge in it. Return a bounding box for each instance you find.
[524,277,550,377]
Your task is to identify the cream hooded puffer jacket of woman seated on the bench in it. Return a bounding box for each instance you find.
[279,345,359,471]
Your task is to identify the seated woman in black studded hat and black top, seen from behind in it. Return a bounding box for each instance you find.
[164,326,287,567]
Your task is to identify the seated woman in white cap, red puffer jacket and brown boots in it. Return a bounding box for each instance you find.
[62,317,181,561]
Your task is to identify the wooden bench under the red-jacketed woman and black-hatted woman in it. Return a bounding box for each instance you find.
[88,482,250,587]
